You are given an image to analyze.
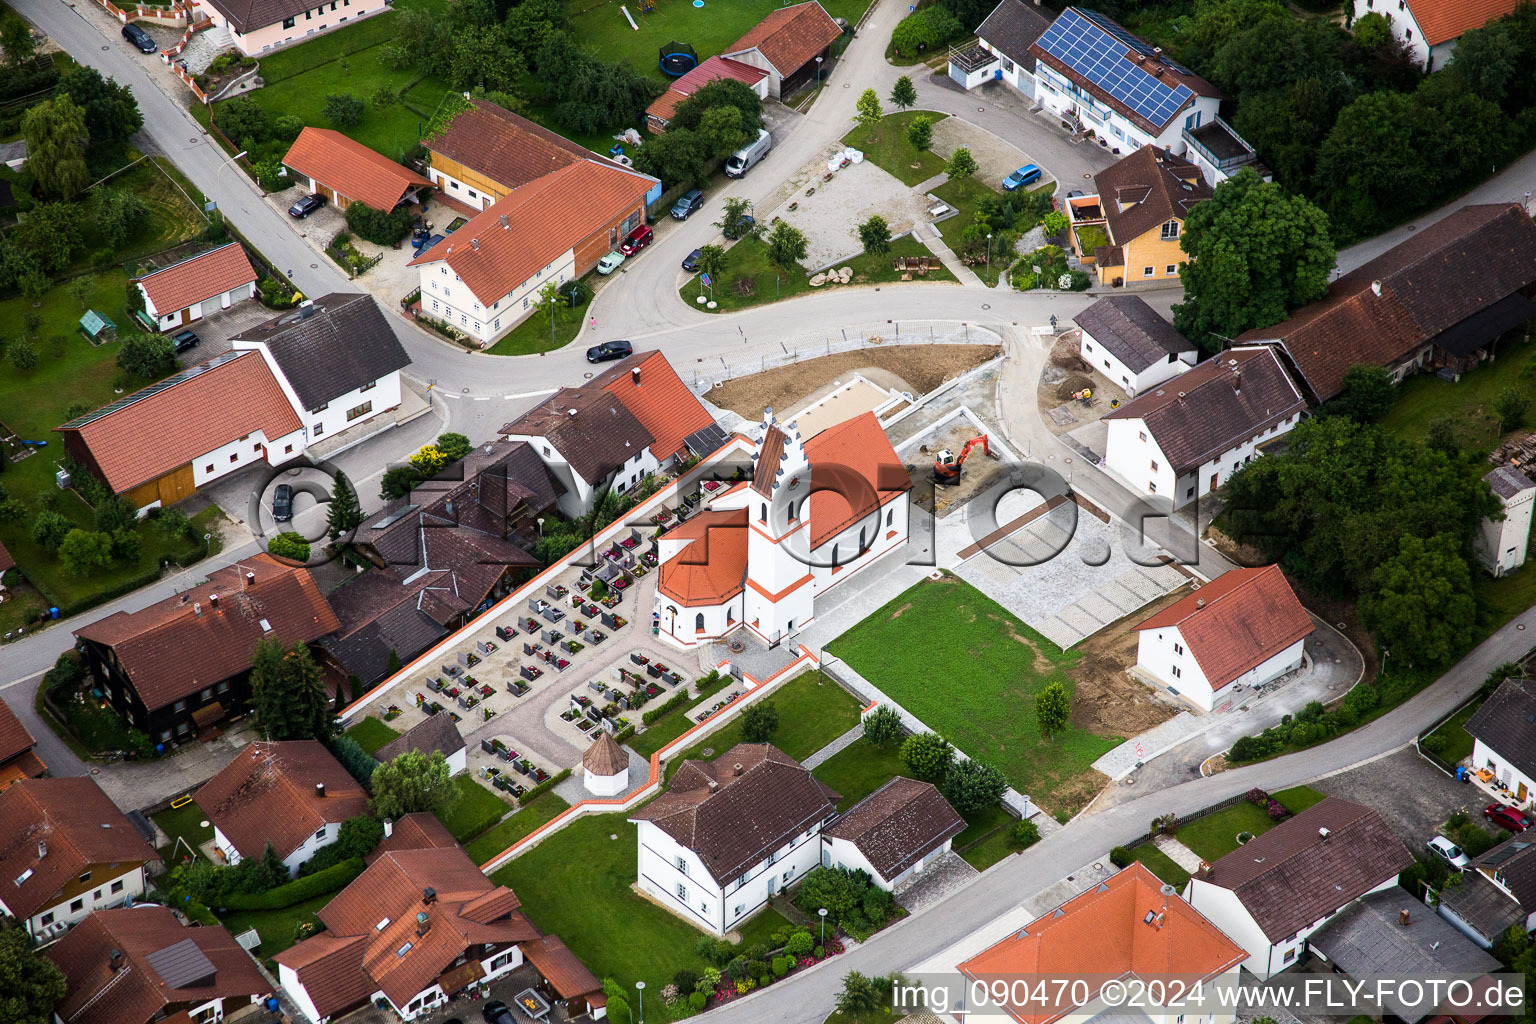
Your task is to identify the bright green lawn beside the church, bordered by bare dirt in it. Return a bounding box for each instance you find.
[828,574,1123,815]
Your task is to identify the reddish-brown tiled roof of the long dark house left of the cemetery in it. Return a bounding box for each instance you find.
[75,555,341,711]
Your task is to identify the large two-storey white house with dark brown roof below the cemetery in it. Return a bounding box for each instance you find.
[630,743,837,935]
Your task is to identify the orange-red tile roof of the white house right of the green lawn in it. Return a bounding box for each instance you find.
[1135,565,1313,689]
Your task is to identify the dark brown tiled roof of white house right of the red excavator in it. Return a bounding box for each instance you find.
[1104,345,1307,474]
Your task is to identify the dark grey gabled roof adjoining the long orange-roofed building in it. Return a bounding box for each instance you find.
[230,292,410,410]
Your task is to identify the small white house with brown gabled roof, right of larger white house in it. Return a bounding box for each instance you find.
[822,775,965,892]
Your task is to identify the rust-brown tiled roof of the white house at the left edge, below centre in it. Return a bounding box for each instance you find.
[0,777,158,921]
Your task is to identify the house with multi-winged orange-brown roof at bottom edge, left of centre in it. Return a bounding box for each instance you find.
[276,840,543,1024]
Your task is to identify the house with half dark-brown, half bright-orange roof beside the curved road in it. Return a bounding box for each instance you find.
[498,352,717,516]
